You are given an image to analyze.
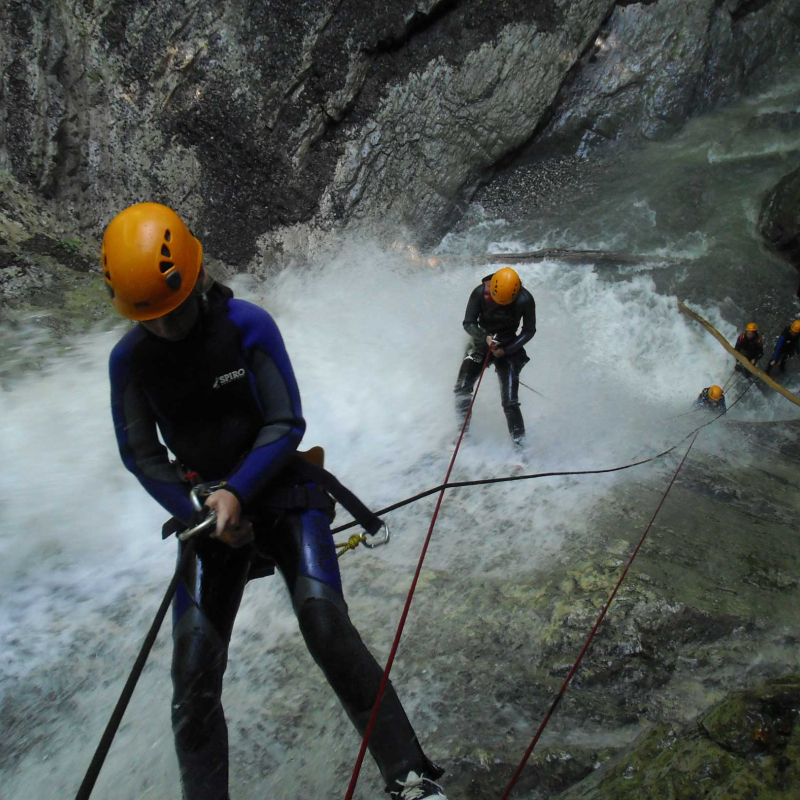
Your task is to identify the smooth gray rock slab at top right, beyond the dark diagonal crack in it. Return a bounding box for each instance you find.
[531,0,800,161]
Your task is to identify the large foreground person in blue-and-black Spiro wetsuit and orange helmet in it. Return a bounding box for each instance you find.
[101,203,444,800]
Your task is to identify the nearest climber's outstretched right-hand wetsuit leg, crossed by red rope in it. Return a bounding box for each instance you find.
[262,510,441,788]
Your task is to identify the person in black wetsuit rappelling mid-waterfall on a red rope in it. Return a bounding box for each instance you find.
[453,267,536,447]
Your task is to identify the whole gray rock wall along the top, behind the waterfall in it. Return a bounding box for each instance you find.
[0,0,800,266]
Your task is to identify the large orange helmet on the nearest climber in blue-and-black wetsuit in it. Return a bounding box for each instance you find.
[101,203,203,321]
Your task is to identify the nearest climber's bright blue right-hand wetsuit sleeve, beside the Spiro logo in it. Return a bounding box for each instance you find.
[225,300,306,505]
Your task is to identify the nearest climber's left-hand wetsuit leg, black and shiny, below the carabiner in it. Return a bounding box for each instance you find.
[172,540,251,800]
